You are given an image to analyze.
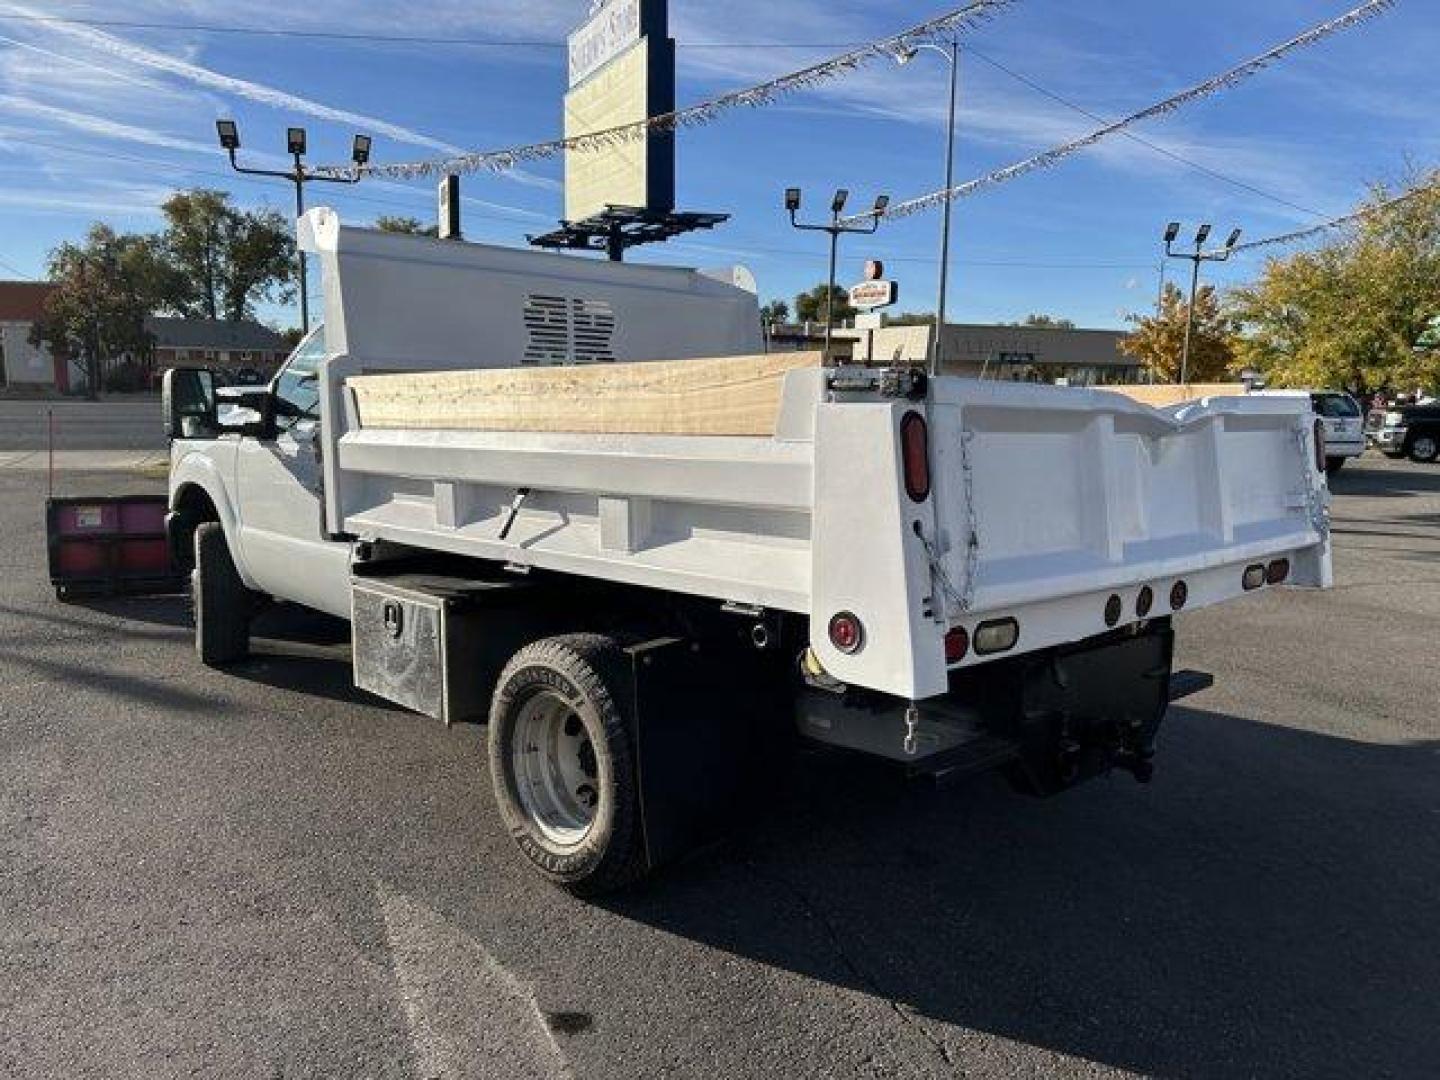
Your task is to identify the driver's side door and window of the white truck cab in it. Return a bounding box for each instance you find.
[235,327,350,618]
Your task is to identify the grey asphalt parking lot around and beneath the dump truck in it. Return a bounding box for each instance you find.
[0,443,1440,1079]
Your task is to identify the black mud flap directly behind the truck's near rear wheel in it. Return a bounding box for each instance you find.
[628,638,788,870]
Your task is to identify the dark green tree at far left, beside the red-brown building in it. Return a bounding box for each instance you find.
[30,225,170,399]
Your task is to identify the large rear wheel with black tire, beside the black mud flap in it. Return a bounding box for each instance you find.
[490,634,645,894]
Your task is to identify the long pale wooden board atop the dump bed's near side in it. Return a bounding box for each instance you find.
[347,353,821,436]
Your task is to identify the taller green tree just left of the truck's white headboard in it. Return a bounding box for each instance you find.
[158,189,295,320]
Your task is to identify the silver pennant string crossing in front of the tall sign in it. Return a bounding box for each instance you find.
[315,0,1017,180]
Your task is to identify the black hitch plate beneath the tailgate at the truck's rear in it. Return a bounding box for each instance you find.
[984,625,1188,795]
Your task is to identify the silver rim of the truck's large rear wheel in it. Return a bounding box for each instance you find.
[510,690,600,848]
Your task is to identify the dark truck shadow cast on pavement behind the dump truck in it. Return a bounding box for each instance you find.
[609,710,1440,1077]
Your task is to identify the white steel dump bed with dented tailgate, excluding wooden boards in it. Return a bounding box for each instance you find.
[304,213,1331,698]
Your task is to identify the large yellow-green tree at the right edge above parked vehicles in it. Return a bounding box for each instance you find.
[1230,170,1440,393]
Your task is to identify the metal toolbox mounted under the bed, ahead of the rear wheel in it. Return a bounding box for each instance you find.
[351,575,523,724]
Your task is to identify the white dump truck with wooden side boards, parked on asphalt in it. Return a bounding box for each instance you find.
[166,210,1331,891]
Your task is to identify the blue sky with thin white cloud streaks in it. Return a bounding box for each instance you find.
[0,0,1440,327]
